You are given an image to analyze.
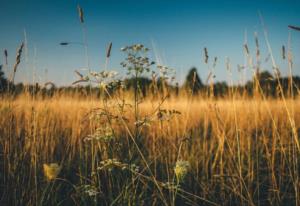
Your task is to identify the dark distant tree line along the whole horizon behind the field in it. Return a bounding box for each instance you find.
[0,65,300,98]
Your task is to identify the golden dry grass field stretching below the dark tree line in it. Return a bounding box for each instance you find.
[0,96,300,205]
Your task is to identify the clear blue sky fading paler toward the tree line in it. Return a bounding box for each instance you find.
[0,0,300,85]
